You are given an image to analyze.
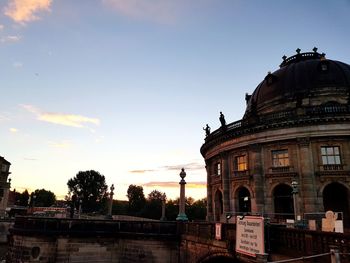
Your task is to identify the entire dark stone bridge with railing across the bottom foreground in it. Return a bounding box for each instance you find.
[7,217,350,263]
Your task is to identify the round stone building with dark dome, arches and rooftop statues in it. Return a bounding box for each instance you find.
[201,48,350,227]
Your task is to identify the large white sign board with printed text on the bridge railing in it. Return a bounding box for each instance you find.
[236,216,265,257]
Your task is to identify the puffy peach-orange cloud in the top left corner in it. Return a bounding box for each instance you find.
[5,0,52,24]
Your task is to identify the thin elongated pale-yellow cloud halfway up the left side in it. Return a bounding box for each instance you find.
[20,105,100,128]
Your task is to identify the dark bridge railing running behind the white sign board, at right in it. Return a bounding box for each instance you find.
[181,223,350,262]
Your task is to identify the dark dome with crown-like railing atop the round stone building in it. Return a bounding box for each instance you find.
[244,48,350,119]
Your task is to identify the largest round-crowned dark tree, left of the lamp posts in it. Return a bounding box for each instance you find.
[67,170,107,212]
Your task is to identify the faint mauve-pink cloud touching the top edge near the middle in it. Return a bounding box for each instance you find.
[102,0,178,24]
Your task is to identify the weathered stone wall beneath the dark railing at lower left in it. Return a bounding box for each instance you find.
[7,235,178,263]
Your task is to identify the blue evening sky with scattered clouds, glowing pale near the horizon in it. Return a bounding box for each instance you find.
[0,0,350,202]
